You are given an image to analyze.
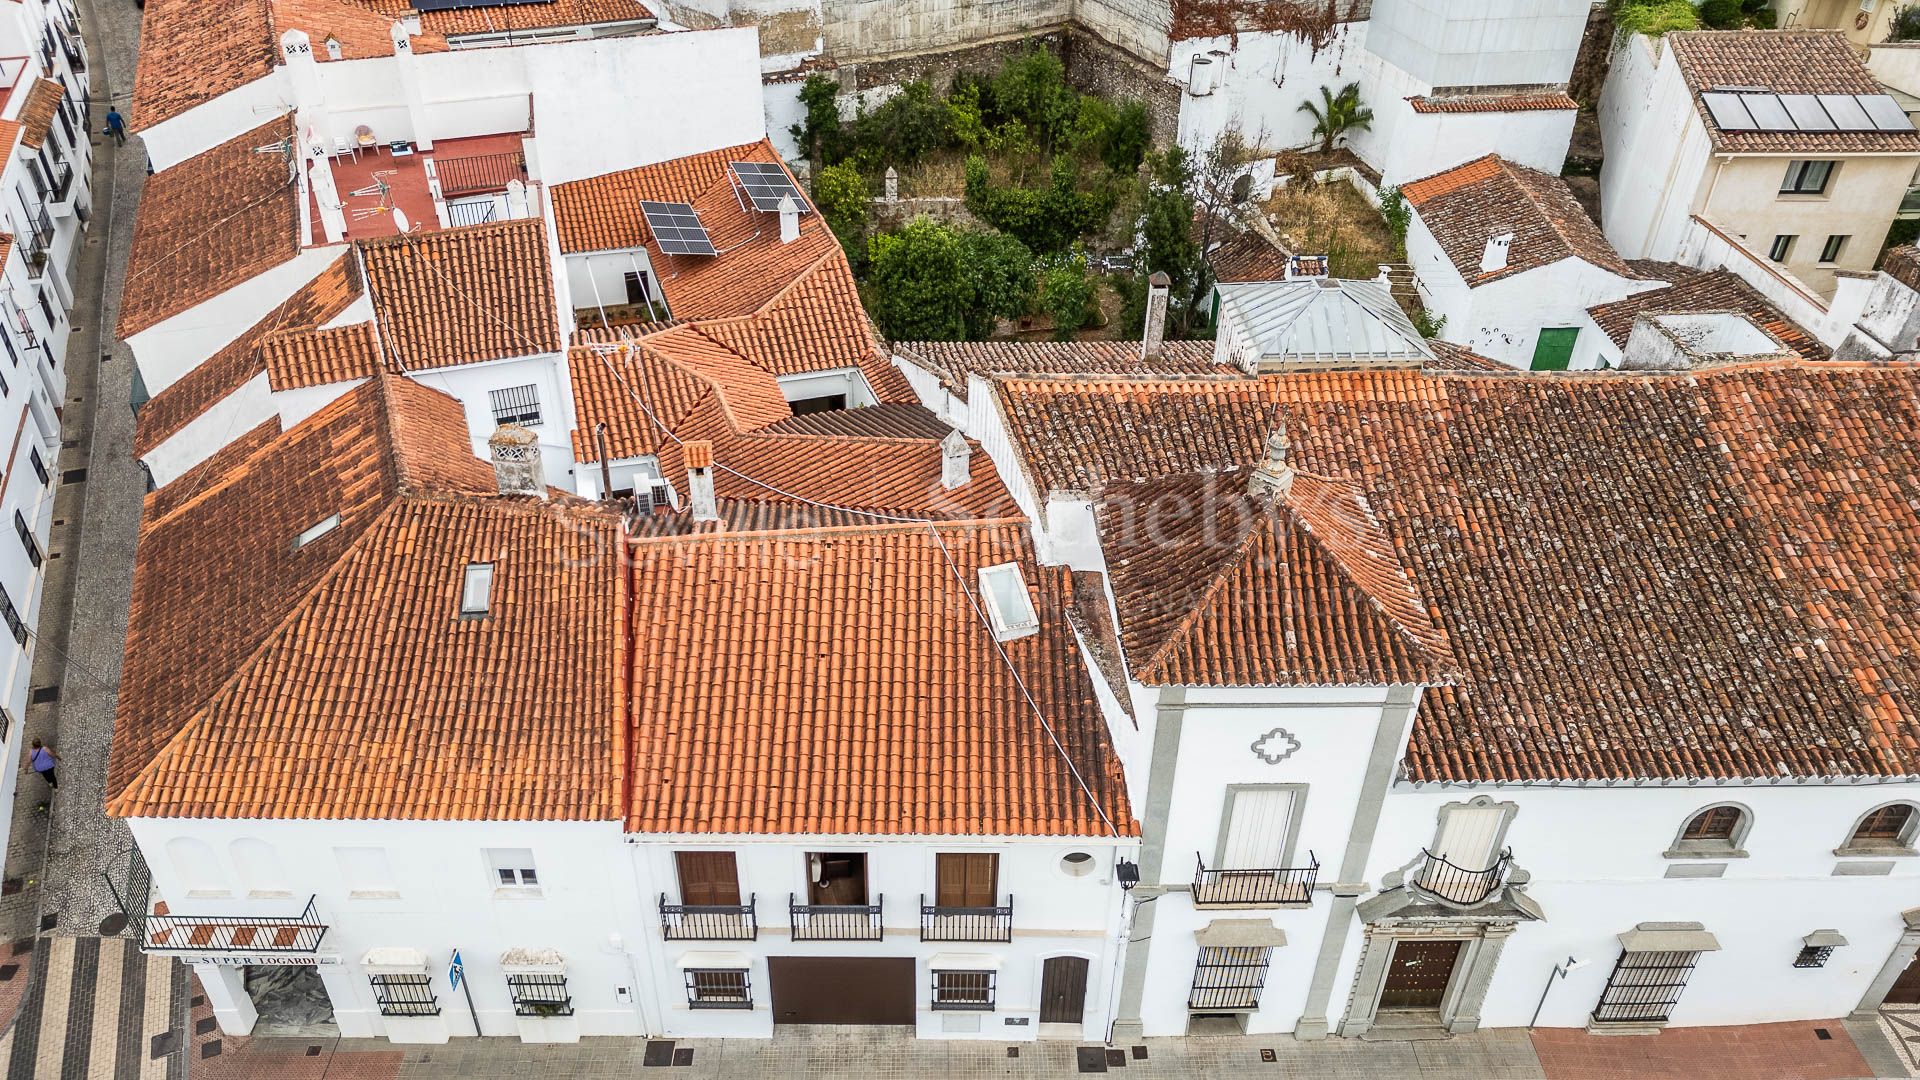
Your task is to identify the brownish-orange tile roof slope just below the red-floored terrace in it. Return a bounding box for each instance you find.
[357,217,566,371]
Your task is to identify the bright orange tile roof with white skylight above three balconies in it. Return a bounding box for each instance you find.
[626,523,1139,836]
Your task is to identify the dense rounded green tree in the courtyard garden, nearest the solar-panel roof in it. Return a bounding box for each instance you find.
[866,217,1033,342]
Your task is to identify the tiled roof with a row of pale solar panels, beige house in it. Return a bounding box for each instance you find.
[1663,31,1920,154]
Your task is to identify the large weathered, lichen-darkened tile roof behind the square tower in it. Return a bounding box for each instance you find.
[998,361,1920,780]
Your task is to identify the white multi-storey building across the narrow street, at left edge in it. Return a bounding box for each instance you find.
[0,2,89,857]
